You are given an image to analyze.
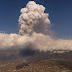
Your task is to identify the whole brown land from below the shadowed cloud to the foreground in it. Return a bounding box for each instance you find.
[0,52,72,72]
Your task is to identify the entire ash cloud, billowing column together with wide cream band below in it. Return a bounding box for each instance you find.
[0,1,72,52]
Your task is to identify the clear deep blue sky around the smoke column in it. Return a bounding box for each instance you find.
[0,0,72,38]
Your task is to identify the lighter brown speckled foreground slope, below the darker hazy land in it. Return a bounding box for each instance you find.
[0,60,72,72]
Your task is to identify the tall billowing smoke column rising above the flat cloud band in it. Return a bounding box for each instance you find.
[19,1,50,35]
